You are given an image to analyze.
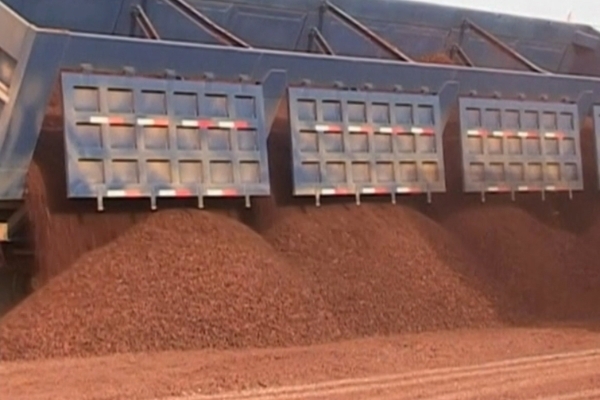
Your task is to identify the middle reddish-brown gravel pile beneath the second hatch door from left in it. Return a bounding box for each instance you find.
[265,204,498,336]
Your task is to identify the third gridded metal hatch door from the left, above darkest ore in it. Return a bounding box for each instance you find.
[460,98,583,192]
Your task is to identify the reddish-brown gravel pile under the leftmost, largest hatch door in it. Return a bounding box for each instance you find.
[0,210,338,360]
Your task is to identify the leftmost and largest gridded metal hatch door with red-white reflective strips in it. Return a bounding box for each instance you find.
[62,73,270,202]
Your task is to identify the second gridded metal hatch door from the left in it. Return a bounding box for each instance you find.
[289,88,446,195]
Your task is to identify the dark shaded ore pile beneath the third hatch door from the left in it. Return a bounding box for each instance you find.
[443,205,582,320]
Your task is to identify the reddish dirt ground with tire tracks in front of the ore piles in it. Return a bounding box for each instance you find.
[0,326,600,400]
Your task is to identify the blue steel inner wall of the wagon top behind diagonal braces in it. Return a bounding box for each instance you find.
[4,0,600,76]
